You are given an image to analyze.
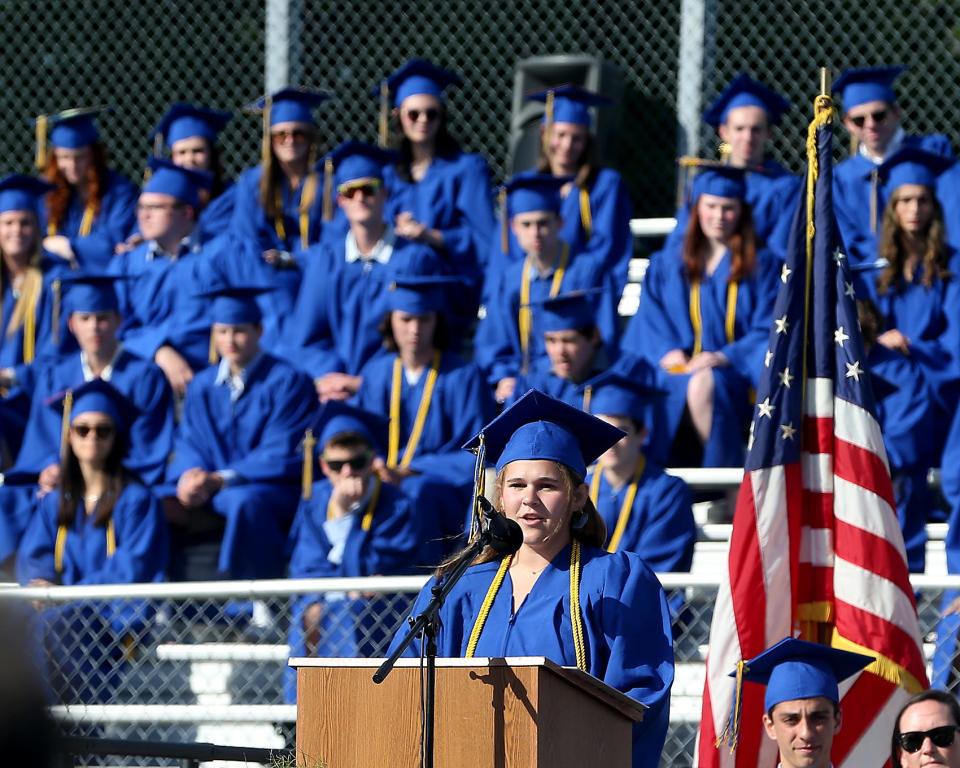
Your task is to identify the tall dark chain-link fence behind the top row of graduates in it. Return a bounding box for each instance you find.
[0,0,960,222]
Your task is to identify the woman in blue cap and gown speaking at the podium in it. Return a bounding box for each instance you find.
[393,390,673,768]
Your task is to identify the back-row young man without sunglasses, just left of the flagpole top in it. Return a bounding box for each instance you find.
[664,74,801,258]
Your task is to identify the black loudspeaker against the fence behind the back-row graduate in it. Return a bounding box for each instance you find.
[507,54,623,174]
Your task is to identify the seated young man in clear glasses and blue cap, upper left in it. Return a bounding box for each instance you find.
[110,157,226,397]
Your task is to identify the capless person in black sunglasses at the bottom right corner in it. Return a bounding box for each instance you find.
[890,689,960,768]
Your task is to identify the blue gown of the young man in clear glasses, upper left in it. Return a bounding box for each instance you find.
[111,238,228,371]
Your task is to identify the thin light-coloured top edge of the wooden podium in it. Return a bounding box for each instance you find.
[288,656,647,722]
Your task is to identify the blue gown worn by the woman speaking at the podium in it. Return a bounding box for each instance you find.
[392,547,674,768]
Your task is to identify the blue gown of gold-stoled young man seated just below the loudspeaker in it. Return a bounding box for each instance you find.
[474,248,620,385]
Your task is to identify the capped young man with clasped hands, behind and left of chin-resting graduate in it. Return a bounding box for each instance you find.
[163,286,316,579]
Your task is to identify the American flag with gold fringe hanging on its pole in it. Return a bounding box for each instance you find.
[697,88,927,768]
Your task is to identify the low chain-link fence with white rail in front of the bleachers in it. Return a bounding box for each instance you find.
[7,574,957,766]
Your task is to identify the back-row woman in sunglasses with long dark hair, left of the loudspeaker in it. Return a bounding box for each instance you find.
[375,59,496,302]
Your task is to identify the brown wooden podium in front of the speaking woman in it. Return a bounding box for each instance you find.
[290,657,644,768]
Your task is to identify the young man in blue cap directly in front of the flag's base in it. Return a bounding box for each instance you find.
[717,637,874,768]
